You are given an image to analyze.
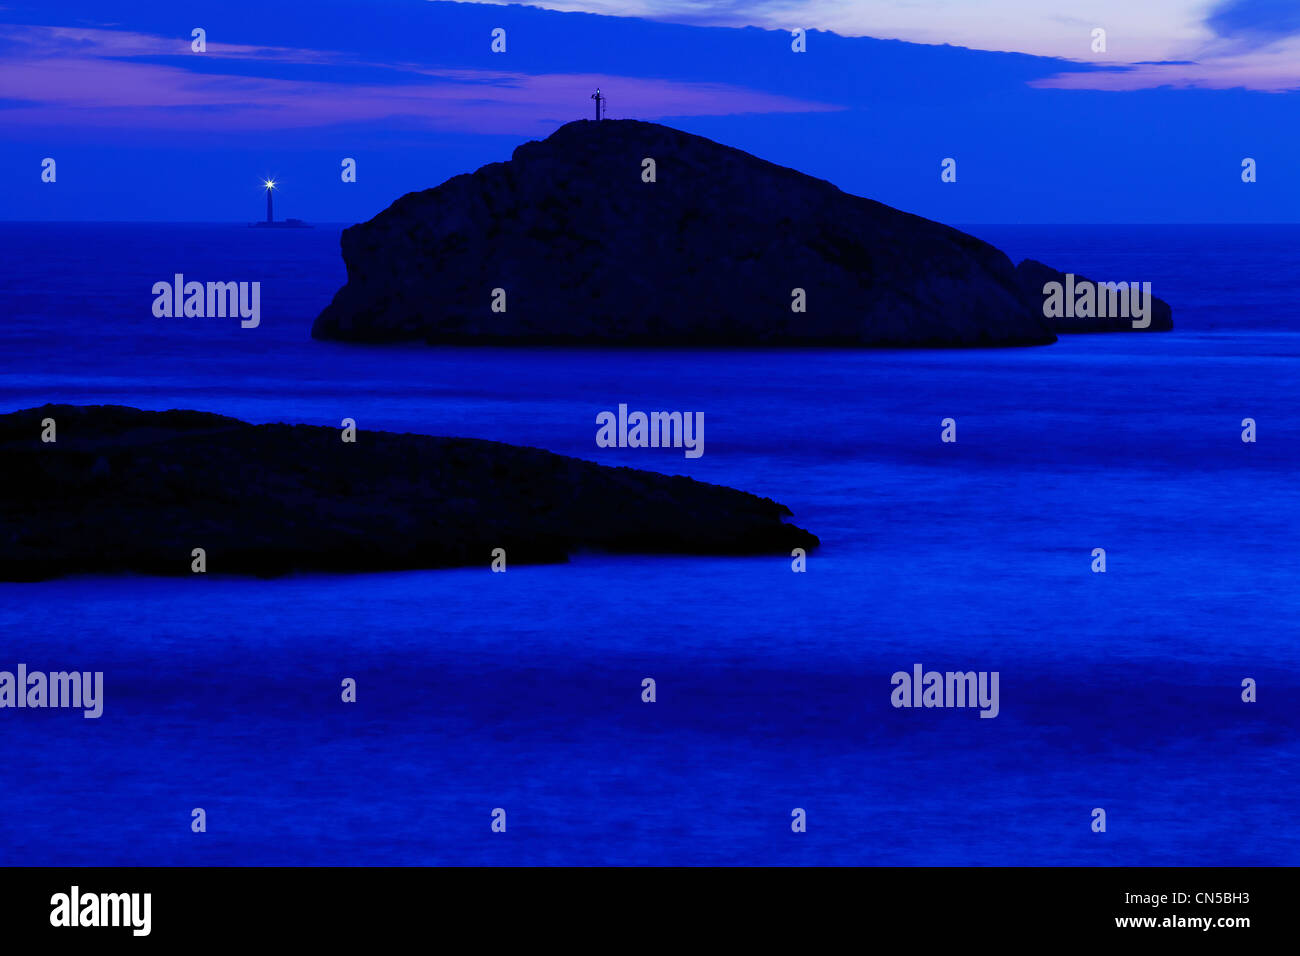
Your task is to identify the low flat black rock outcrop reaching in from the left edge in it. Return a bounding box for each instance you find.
[0,406,818,580]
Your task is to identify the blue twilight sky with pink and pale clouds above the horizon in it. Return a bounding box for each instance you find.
[0,0,1300,222]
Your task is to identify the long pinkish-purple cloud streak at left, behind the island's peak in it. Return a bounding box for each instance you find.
[0,27,842,133]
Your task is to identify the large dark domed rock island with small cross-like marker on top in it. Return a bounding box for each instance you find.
[312,120,1056,346]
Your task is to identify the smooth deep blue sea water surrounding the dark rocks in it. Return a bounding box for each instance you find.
[0,224,1300,865]
